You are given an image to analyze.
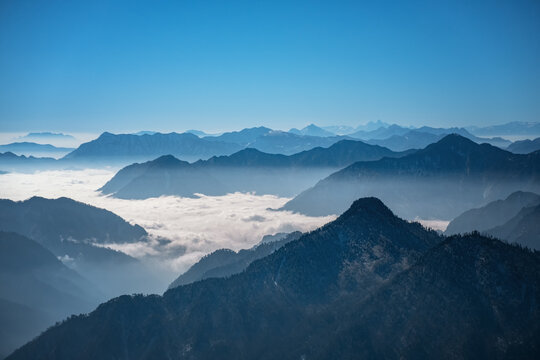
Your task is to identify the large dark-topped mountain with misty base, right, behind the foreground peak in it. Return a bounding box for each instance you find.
[284,135,540,220]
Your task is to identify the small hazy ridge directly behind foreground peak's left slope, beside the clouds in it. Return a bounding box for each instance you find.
[169,231,302,289]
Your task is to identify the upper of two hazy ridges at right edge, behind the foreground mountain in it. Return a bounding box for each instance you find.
[445,191,540,239]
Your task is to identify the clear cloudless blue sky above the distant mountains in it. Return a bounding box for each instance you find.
[0,0,540,132]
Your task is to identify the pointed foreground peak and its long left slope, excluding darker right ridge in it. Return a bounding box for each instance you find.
[5,199,440,359]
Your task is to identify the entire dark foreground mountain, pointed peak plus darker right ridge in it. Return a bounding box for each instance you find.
[8,198,540,360]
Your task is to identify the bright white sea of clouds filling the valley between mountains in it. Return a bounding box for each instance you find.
[0,169,335,280]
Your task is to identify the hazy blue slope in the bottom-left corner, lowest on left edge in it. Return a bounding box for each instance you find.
[0,231,98,358]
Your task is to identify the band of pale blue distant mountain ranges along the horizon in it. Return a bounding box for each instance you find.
[0,121,538,171]
